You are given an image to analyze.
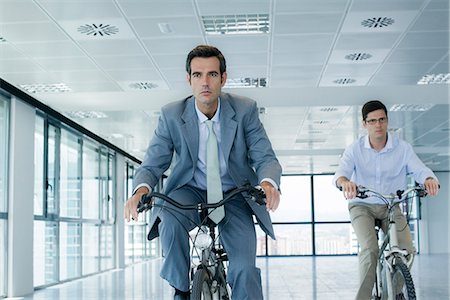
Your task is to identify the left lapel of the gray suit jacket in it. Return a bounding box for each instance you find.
[181,97,199,165]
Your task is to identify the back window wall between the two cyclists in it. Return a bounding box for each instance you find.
[257,175,358,256]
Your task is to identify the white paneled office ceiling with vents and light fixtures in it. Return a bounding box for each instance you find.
[0,0,450,174]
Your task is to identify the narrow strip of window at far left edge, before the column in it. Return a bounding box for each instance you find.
[0,95,9,297]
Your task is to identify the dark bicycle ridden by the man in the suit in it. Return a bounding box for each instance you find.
[138,184,265,300]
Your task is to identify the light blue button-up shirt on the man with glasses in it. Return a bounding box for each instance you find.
[333,132,437,204]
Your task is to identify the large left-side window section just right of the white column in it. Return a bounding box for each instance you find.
[34,114,116,287]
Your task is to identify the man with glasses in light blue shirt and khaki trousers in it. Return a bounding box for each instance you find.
[333,100,439,300]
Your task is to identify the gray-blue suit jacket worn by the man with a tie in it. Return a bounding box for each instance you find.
[134,93,281,239]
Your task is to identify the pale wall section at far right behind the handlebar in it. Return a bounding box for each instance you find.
[419,172,450,254]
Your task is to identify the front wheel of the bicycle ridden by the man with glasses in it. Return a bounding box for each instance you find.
[391,260,416,300]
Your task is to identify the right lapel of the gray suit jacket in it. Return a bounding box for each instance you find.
[220,94,237,164]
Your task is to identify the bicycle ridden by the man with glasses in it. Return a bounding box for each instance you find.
[357,185,427,300]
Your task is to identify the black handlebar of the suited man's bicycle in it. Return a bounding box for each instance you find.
[137,184,266,213]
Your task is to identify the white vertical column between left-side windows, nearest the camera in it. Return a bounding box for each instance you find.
[8,98,36,297]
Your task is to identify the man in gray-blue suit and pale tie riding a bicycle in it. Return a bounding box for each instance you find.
[124,45,281,300]
